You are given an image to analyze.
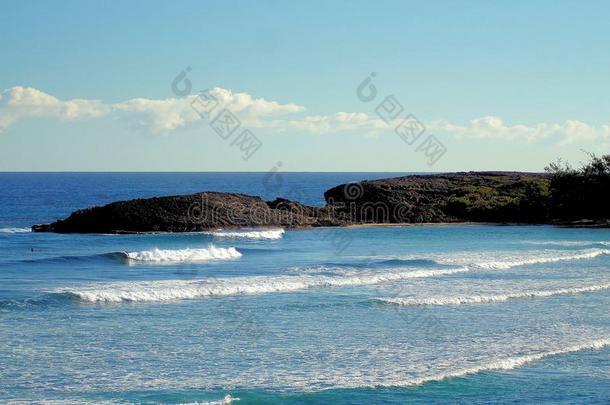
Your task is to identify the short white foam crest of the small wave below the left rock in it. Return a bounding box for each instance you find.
[125,245,242,262]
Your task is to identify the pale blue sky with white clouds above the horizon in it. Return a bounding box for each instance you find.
[0,0,610,172]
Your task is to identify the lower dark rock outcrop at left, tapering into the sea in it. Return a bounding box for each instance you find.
[32,192,324,233]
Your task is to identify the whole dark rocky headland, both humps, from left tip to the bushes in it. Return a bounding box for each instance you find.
[32,172,548,233]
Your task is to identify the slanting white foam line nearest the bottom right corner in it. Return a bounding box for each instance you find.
[390,339,610,386]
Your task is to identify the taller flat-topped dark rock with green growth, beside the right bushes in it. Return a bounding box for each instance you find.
[324,172,548,223]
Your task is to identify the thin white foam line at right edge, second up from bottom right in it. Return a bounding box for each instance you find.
[374,283,610,306]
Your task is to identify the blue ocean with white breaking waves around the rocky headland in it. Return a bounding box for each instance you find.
[0,172,610,405]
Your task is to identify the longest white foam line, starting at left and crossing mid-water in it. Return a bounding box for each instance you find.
[50,268,468,303]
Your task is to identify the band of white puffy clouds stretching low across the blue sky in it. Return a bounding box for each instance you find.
[0,86,610,144]
